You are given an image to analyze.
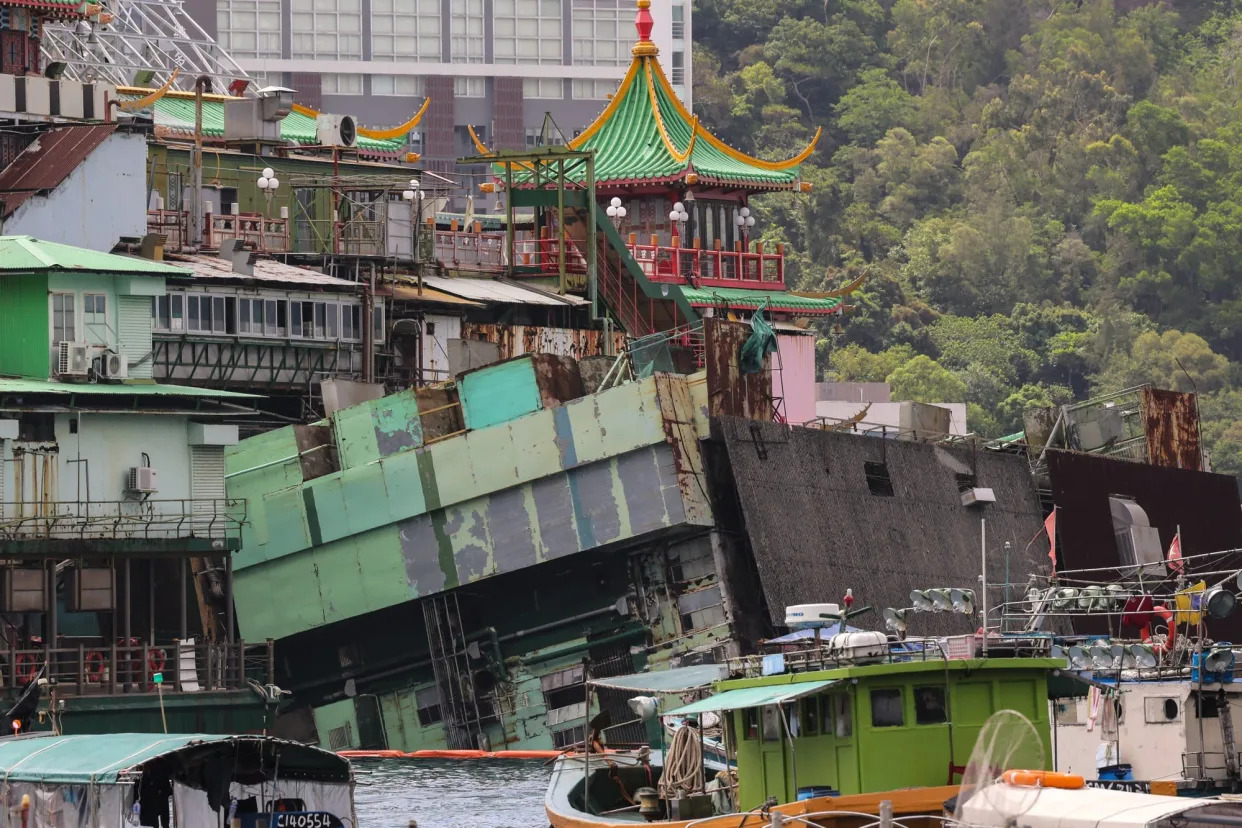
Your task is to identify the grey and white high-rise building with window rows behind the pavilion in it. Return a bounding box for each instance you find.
[186,0,691,170]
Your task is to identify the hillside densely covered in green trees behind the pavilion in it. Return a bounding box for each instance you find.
[694,0,1242,473]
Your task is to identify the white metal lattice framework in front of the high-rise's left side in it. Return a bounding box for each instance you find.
[41,0,255,93]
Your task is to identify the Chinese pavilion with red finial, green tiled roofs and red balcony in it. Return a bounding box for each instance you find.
[466,0,856,335]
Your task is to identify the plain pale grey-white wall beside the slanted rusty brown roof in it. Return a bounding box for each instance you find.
[4,132,147,251]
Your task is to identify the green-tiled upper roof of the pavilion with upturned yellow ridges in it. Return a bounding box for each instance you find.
[504,55,818,190]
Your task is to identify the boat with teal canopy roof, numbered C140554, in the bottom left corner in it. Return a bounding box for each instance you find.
[0,734,356,828]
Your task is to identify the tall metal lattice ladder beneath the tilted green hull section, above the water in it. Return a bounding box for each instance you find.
[422,592,482,750]
